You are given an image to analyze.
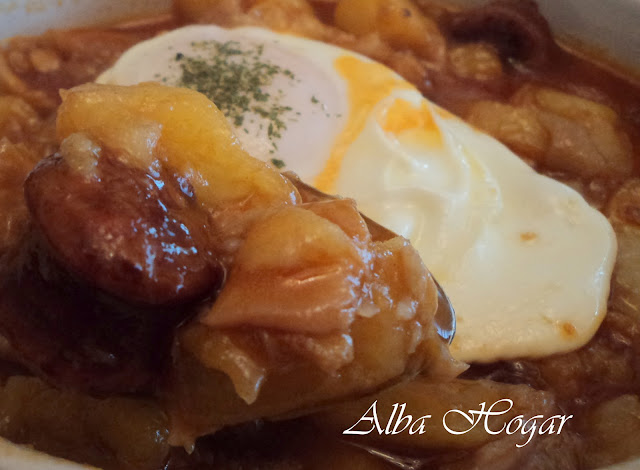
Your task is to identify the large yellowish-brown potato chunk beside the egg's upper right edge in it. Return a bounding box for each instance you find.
[467,85,633,178]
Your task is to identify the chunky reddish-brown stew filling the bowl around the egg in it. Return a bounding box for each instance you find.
[0,0,640,470]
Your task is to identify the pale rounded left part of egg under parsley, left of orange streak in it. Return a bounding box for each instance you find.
[97,26,349,180]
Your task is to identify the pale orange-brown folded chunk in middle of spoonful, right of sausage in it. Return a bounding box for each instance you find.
[200,205,370,334]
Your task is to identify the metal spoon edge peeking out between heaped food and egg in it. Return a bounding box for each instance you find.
[282,171,456,344]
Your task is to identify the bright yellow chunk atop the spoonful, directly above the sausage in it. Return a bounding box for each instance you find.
[57,83,299,210]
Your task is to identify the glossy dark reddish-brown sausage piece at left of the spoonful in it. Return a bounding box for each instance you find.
[25,149,224,305]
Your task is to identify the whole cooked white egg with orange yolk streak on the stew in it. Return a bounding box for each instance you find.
[99,26,616,362]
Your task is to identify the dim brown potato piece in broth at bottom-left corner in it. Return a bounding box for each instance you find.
[0,376,169,470]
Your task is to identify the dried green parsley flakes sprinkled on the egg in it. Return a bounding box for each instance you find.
[175,41,295,153]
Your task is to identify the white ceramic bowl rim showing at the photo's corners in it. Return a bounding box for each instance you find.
[0,0,640,470]
